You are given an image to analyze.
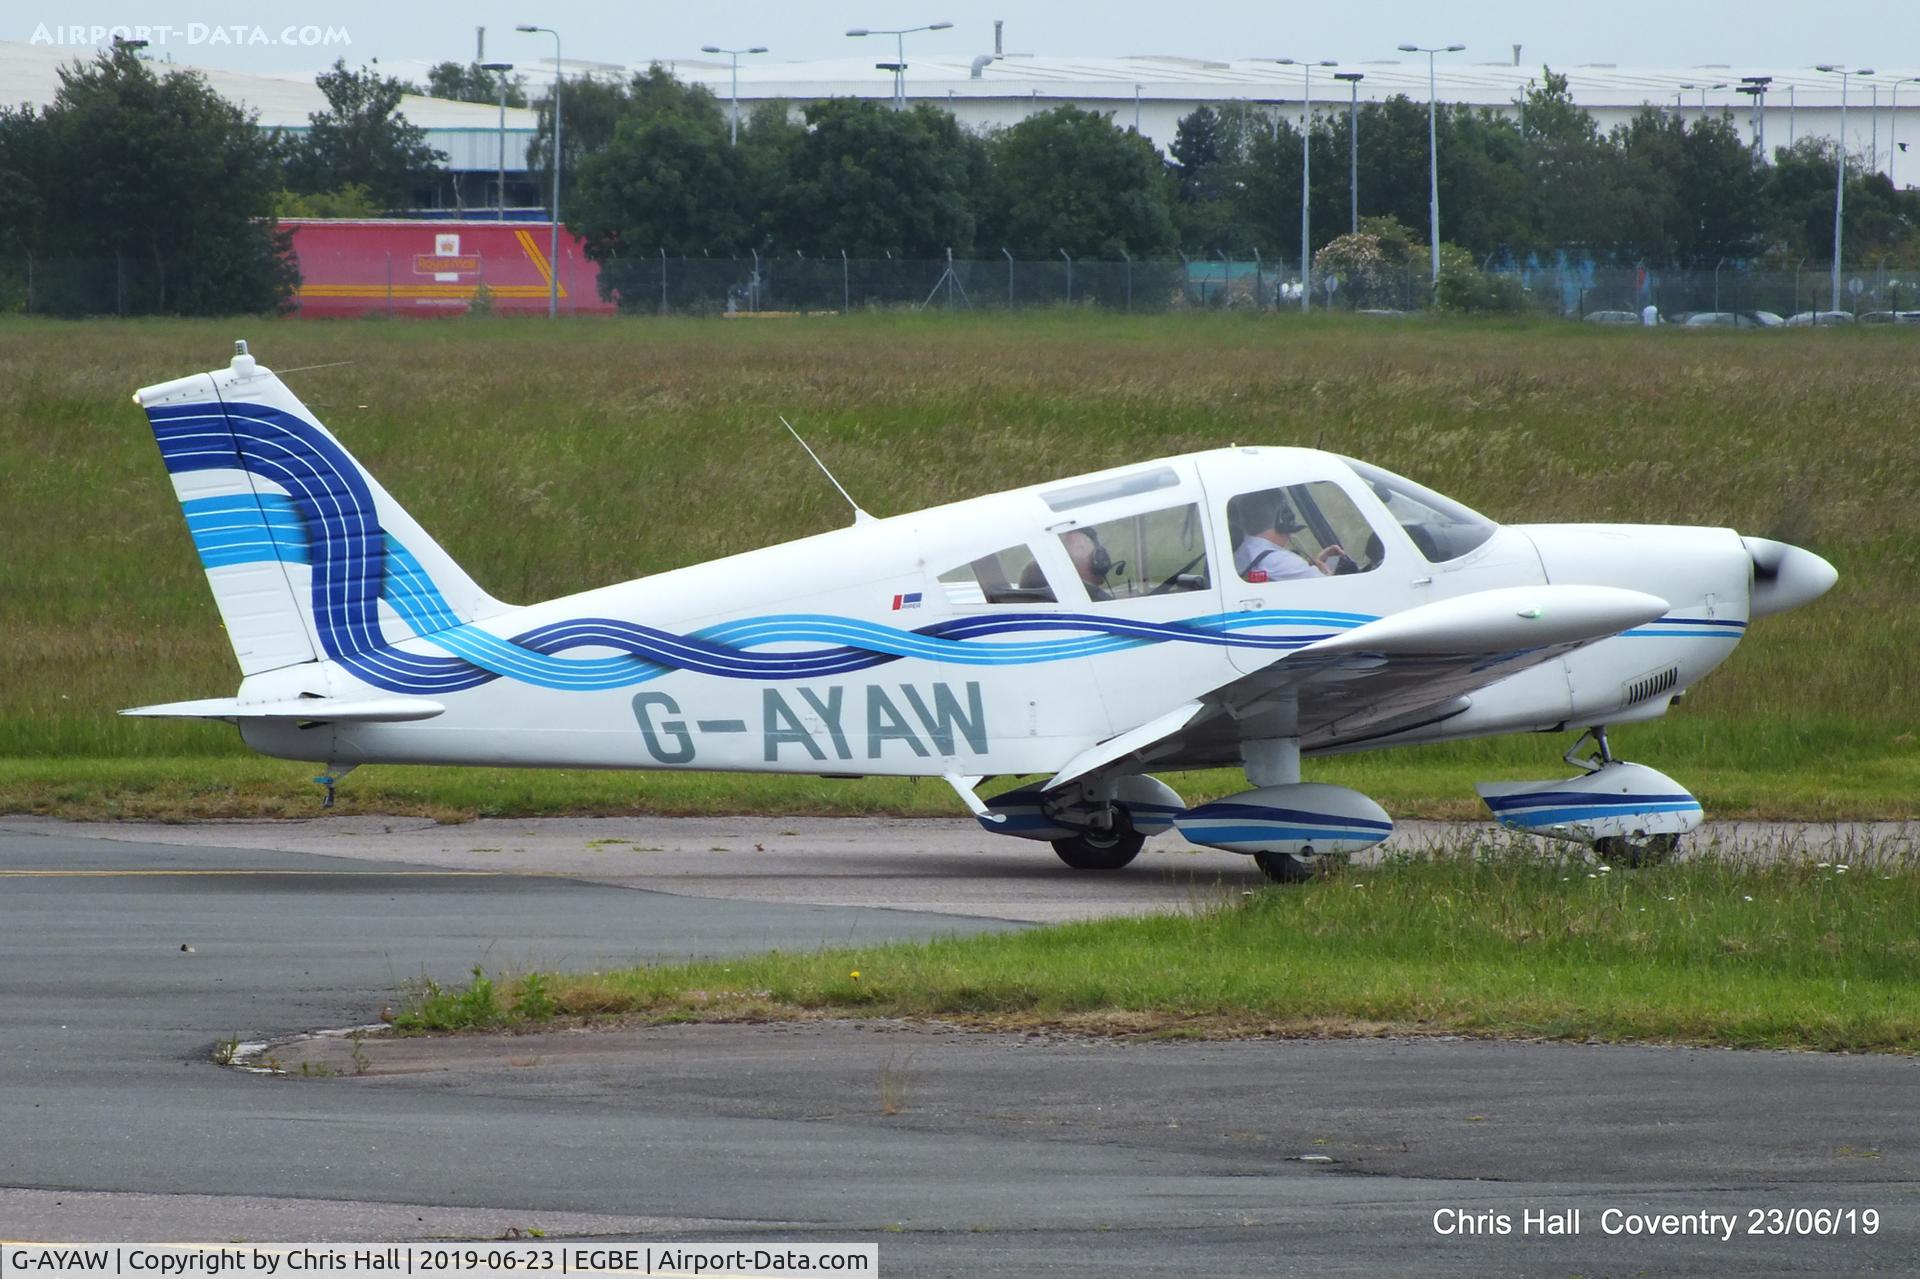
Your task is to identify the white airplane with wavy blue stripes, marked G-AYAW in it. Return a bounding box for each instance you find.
[123,342,1837,881]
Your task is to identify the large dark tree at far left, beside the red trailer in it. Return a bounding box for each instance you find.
[0,46,298,315]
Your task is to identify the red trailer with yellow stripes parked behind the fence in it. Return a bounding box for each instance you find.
[280,219,614,315]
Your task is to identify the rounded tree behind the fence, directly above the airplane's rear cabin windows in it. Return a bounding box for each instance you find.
[987,106,1179,259]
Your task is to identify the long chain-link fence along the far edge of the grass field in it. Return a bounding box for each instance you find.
[0,253,1920,318]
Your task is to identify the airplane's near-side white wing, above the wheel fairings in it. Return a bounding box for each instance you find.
[1043,586,1668,789]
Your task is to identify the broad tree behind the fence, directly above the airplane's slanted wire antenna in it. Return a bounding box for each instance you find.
[770,98,983,257]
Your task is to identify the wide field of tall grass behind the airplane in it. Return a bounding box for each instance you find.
[0,313,1920,818]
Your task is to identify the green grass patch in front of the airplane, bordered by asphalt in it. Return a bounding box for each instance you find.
[396,845,1920,1052]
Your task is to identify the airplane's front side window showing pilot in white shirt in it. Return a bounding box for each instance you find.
[1227,480,1386,582]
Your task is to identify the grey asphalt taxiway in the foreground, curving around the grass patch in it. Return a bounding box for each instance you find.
[0,820,1920,1275]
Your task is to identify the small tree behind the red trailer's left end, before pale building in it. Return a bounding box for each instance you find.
[286,60,445,209]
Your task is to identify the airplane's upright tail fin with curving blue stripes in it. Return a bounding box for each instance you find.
[134,342,505,675]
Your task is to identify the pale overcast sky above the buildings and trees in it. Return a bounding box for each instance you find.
[15,0,1920,77]
